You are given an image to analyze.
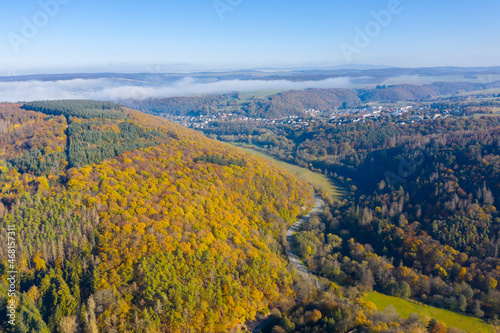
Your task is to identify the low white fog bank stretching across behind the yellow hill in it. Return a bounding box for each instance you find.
[0,77,354,103]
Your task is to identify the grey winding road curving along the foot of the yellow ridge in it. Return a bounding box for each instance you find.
[252,195,325,333]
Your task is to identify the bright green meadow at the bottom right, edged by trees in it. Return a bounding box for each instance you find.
[364,292,495,333]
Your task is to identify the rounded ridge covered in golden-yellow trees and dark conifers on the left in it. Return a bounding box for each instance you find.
[0,101,314,332]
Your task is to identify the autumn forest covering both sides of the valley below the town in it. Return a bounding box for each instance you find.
[0,99,500,333]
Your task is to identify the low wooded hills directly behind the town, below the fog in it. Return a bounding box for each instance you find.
[123,81,500,119]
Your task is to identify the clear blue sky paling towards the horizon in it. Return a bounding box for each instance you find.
[0,0,500,75]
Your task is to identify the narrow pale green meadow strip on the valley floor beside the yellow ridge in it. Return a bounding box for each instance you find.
[231,144,345,199]
